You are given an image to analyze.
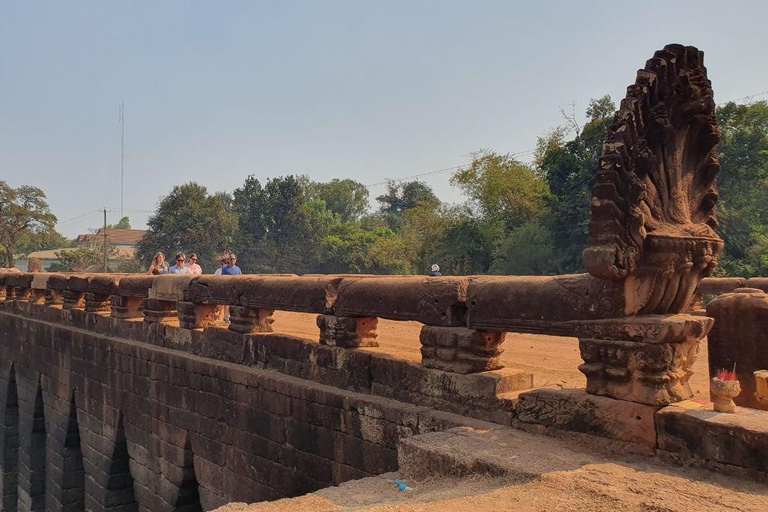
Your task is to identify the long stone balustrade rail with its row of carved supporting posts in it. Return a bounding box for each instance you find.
[0,273,711,405]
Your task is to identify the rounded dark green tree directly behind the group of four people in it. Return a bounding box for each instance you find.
[137,183,237,272]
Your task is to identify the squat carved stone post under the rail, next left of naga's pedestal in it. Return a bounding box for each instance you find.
[420,325,506,373]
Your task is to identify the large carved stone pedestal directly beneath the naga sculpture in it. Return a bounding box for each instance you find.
[575,314,713,405]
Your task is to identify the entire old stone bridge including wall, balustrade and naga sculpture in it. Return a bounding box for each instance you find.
[0,45,768,512]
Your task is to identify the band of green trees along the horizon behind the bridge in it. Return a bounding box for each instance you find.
[12,96,768,276]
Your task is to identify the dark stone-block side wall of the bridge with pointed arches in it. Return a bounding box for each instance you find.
[0,304,480,512]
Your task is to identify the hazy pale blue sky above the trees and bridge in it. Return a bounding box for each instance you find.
[0,0,768,236]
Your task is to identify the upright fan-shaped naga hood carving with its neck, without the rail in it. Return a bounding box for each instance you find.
[584,45,723,314]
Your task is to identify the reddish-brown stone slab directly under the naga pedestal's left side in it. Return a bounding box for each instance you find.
[515,389,660,447]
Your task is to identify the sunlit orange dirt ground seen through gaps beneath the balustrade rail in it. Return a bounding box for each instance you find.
[273,311,709,397]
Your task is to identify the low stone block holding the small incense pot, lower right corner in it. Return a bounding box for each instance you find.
[656,400,768,480]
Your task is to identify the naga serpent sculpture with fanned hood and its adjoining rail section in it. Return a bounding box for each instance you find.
[470,44,724,332]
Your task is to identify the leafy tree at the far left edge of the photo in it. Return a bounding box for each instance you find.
[0,181,56,267]
